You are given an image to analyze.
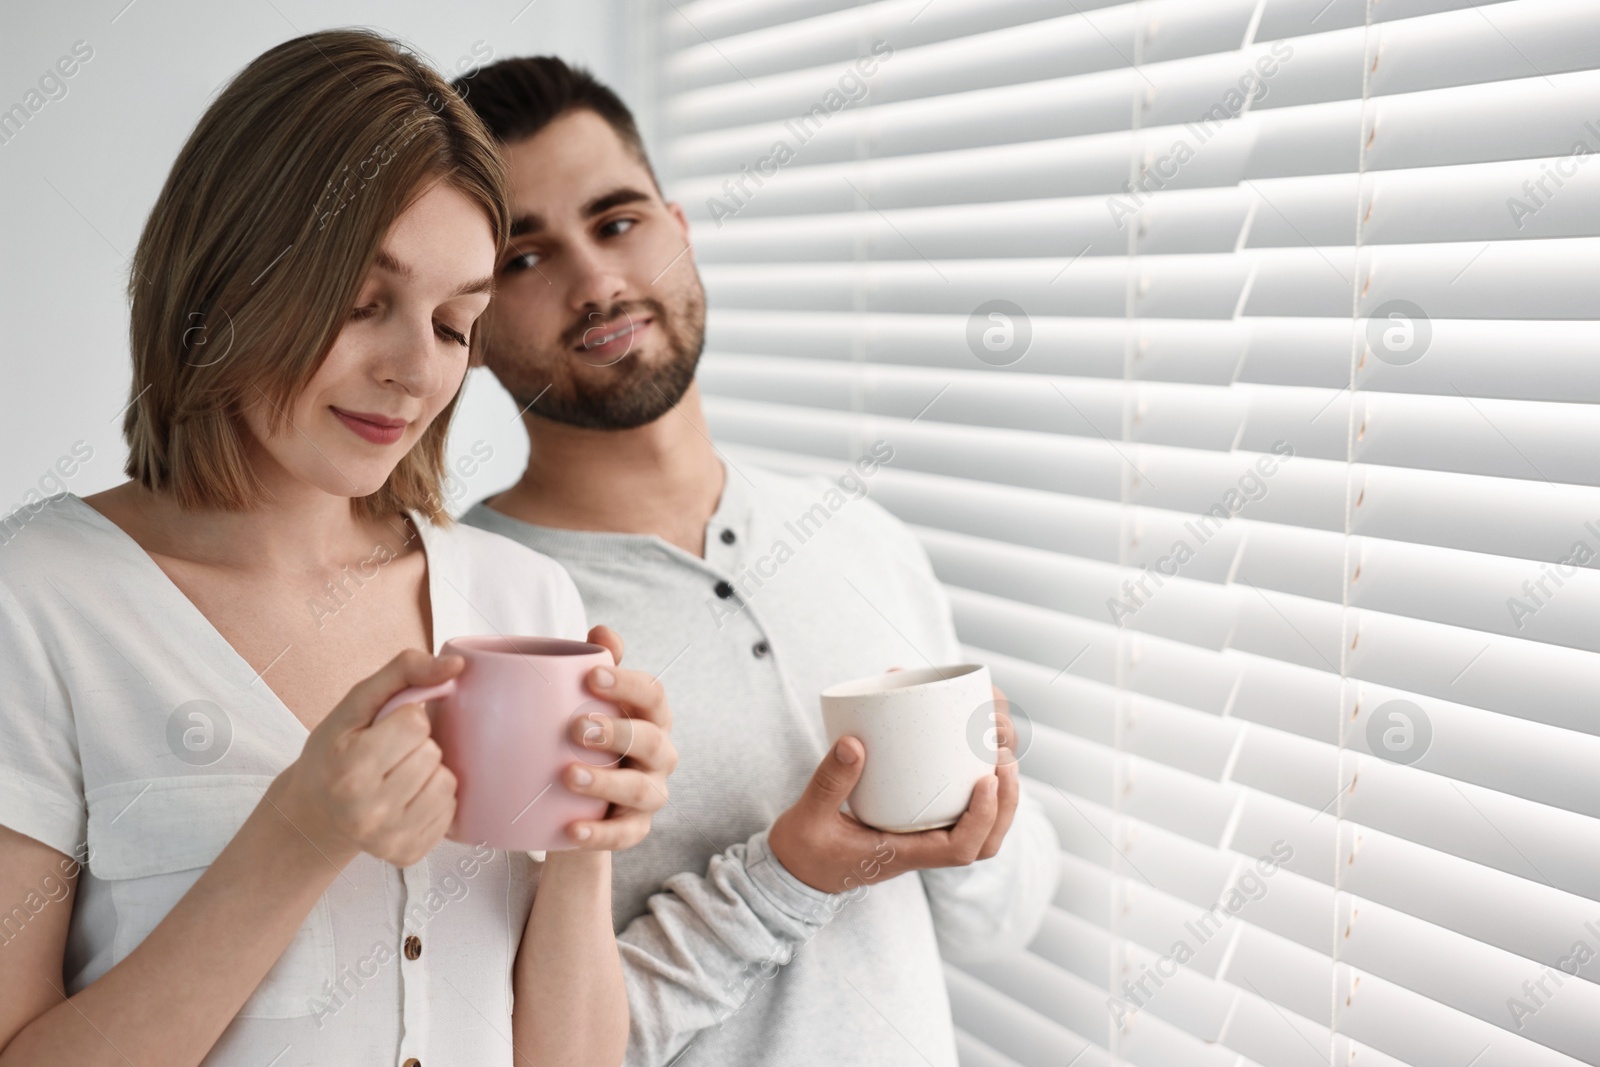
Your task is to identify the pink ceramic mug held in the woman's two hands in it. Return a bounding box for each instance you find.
[373,637,619,851]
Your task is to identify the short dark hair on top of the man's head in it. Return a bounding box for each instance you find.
[451,56,661,189]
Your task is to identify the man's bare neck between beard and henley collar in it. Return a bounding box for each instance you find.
[488,384,725,557]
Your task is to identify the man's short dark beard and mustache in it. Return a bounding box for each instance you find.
[486,278,706,430]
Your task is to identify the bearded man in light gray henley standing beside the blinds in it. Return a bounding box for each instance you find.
[458,58,1058,1067]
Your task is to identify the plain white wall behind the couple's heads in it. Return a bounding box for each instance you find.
[0,0,648,515]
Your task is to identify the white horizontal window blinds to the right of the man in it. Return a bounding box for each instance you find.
[658,0,1600,1067]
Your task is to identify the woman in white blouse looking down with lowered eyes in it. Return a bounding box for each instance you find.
[0,32,675,1067]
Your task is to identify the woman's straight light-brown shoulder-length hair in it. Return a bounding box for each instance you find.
[123,29,510,523]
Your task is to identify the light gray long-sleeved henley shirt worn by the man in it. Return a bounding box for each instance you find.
[462,458,1058,1067]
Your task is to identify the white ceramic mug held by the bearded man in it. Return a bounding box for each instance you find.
[822,664,995,833]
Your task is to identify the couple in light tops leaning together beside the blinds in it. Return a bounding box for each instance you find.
[0,30,1056,1067]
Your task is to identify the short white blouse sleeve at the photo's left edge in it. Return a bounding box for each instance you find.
[0,582,88,856]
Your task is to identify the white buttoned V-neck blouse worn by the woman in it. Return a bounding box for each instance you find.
[0,493,587,1067]
